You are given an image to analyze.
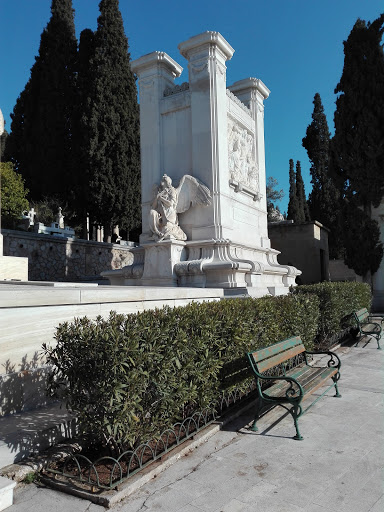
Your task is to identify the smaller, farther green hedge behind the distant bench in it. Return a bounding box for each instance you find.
[293,282,372,344]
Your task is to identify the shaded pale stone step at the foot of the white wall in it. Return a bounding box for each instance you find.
[0,404,76,472]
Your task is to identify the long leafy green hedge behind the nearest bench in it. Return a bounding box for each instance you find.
[44,294,319,451]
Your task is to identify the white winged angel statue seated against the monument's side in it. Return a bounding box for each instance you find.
[149,174,212,242]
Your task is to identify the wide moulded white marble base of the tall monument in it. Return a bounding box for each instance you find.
[102,239,301,297]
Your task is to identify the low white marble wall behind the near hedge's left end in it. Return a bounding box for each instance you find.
[0,282,224,417]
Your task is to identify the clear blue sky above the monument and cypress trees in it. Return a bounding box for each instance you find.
[0,0,384,211]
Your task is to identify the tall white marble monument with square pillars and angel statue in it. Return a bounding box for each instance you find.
[103,32,301,296]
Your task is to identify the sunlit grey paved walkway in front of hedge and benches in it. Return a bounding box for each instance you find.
[8,341,384,512]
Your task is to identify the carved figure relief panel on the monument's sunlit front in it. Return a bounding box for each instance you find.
[228,118,259,192]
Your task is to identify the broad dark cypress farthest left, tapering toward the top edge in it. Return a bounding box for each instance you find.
[5,0,77,204]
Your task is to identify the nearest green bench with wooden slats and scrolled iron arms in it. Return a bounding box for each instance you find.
[247,336,341,440]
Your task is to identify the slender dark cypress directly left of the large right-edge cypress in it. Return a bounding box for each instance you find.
[303,93,343,258]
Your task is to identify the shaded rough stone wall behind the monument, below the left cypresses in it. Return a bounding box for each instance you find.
[2,229,133,282]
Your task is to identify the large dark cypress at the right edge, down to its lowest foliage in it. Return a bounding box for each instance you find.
[332,14,384,280]
